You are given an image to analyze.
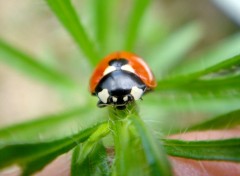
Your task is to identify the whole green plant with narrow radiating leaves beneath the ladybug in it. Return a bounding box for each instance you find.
[0,0,240,175]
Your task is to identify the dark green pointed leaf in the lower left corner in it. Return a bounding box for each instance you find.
[0,124,106,175]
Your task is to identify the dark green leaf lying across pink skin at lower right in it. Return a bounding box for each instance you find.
[163,138,240,162]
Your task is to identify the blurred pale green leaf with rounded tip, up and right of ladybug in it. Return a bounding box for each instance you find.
[146,22,202,78]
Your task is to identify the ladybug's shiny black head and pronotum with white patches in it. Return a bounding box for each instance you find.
[95,69,146,109]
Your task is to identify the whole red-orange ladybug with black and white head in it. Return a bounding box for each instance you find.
[89,51,157,109]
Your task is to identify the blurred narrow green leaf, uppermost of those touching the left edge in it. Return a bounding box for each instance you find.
[0,39,76,88]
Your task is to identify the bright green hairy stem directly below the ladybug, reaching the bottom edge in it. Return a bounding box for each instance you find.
[109,103,172,176]
